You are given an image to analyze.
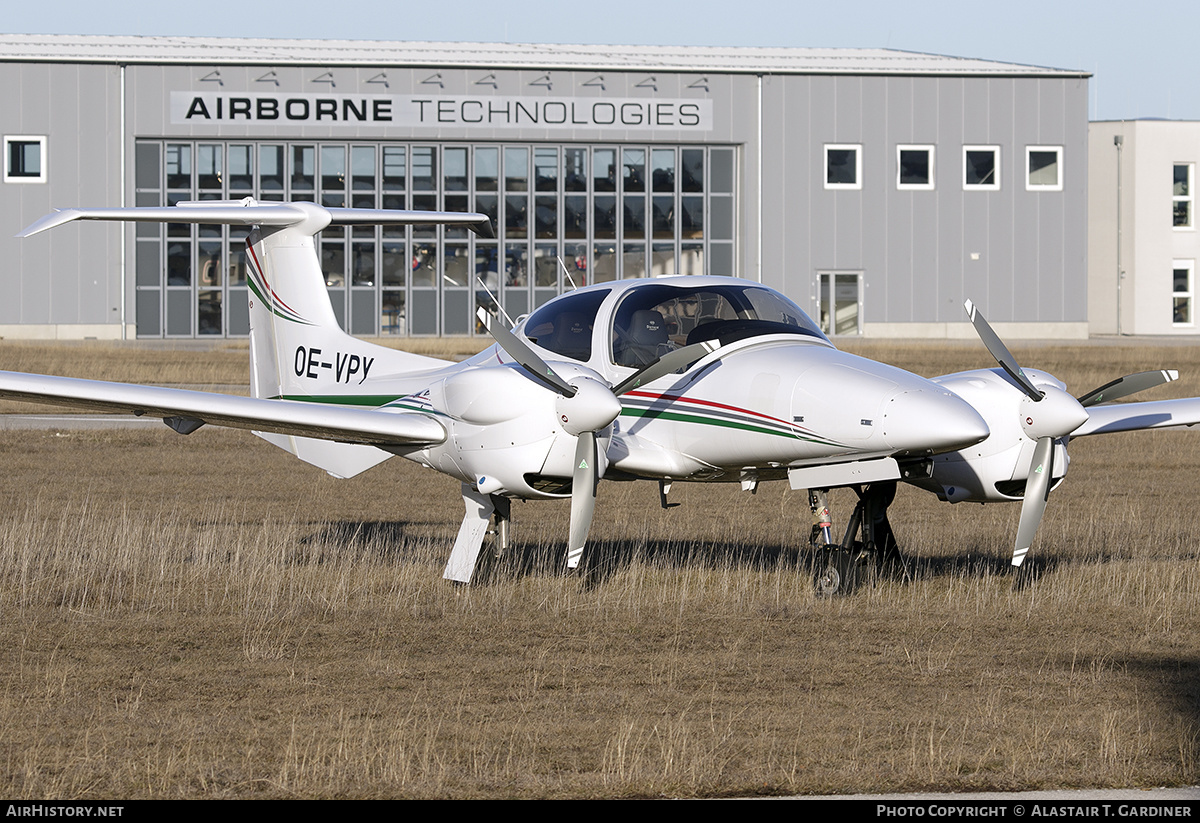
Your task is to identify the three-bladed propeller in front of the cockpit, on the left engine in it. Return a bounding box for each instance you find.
[478,308,720,569]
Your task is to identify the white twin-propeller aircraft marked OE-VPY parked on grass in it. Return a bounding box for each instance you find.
[0,198,1200,594]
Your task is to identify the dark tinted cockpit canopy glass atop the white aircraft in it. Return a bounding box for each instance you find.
[524,282,829,368]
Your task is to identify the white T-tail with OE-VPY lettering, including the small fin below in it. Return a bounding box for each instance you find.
[19,198,492,477]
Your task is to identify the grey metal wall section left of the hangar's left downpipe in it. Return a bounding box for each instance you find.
[0,64,124,325]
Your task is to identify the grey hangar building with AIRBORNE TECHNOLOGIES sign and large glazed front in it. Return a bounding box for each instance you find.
[0,35,1088,338]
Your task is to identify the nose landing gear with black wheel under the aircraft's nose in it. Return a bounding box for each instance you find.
[809,480,904,597]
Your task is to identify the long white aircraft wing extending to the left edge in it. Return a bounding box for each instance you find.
[0,372,446,446]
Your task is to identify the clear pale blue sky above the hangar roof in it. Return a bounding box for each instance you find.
[9,0,1200,120]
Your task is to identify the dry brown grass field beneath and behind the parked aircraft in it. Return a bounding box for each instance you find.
[0,343,1200,799]
